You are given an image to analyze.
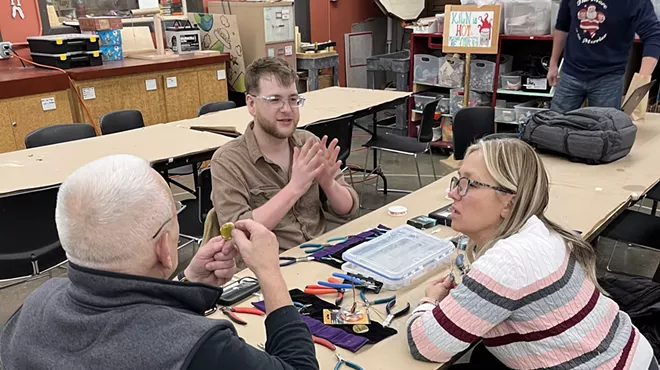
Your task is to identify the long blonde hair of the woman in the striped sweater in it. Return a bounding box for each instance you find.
[466,139,602,291]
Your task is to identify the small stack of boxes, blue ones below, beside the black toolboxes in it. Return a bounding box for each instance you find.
[78,17,124,62]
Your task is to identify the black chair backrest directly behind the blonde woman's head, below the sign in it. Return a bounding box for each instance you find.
[452,107,495,160]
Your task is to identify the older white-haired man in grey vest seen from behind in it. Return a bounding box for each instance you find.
[0,155,318,370]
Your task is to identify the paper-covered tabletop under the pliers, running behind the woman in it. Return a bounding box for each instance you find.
[204,114,660,370]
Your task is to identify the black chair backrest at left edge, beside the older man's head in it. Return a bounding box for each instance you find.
[0,186,66,280]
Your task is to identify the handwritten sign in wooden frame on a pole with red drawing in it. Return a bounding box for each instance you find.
[442,5,501,54]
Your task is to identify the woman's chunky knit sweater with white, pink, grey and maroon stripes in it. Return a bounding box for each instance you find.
[407,217,653,370]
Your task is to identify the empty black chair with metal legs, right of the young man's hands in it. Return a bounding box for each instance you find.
[360,99,439,193]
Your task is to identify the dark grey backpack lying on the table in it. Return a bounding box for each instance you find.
[521,107,637,164]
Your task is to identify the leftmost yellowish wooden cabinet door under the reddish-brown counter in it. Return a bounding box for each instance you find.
[0,91,73,152]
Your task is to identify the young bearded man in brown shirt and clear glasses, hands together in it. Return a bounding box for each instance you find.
[211,57,359,249]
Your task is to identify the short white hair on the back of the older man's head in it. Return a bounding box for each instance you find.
[55,155,176,270]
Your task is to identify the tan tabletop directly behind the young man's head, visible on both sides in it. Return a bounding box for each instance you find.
[169,86,410,133]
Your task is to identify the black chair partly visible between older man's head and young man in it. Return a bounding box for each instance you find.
[177,168,213,249]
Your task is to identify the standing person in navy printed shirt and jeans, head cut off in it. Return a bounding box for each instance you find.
[548,0,660,113]
